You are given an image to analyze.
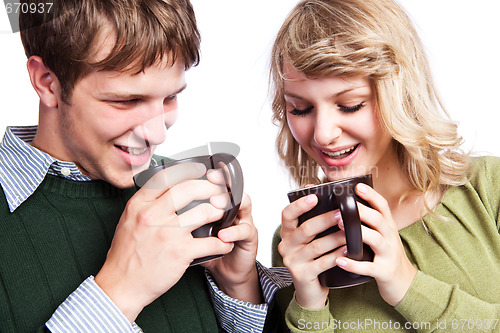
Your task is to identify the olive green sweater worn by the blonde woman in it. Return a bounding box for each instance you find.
[273,157,500,332]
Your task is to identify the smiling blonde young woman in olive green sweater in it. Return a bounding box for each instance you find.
[271,0,500,332]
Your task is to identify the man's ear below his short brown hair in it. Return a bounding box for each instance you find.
[27,56,61,108]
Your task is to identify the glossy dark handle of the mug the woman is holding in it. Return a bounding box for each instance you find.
[333,185,363,260]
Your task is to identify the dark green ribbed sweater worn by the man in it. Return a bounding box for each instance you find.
[0,175,222,333]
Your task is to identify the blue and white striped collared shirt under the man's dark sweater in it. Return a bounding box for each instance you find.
[0,126,291,333]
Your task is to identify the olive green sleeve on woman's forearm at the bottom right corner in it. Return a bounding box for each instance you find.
[395,271,500,332]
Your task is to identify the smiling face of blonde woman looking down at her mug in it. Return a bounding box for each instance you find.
[284,64,396,181]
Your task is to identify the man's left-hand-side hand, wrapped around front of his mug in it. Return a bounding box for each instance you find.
[95,163,233,322]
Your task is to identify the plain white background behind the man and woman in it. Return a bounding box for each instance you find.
[0,0,500,265]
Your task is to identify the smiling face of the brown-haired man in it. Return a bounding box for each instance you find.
[53,61,186,188]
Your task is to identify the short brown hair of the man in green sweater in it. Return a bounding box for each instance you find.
[19,0,200,104]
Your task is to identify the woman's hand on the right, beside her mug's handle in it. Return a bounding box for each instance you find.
[336,184,417,306]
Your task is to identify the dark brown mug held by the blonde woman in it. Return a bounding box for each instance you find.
[288,175,374,288]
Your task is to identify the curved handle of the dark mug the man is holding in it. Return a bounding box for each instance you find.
[210,153,243,237]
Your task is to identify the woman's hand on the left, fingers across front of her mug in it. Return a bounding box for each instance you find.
[278,194,345,309]
